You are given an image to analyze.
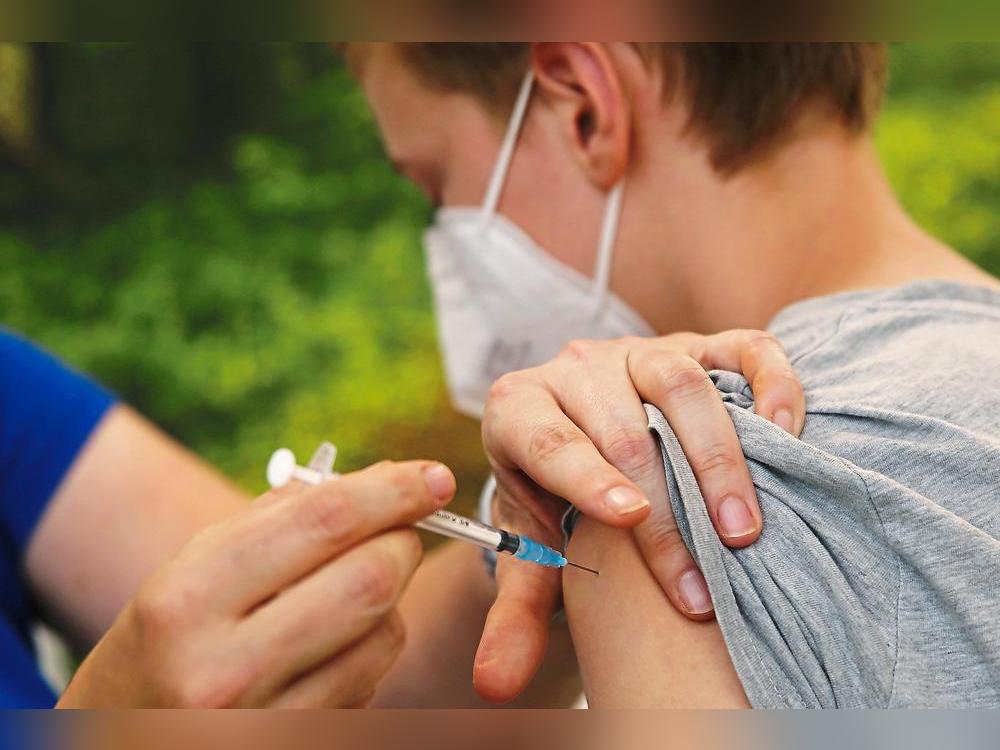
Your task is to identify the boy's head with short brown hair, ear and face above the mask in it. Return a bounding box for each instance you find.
[347,43,886,332]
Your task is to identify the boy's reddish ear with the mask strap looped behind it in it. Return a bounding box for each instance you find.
[532,42,631,190]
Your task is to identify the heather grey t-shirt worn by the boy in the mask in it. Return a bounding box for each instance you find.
[647,282,1000,708]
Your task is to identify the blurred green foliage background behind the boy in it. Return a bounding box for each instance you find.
[0,44,1000,507]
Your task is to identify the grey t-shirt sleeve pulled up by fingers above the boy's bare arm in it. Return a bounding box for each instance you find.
[646,373,899,708]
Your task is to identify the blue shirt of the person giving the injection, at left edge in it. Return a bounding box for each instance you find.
[0,329,114,708]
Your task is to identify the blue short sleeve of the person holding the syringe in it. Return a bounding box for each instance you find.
[0,329,115,555]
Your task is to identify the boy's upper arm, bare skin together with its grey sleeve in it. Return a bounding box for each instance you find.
[565,400,898,707]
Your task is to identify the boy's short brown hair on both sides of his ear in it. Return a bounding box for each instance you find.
[394,43,886,172]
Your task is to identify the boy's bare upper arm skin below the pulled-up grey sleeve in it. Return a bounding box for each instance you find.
[563,519,749,708]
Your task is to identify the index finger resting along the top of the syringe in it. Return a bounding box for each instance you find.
[184,461,455,613]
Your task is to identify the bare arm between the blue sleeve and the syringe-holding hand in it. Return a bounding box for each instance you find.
[27,406,250,648]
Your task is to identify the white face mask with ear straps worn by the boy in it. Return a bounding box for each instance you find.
[424,73,654,418]
